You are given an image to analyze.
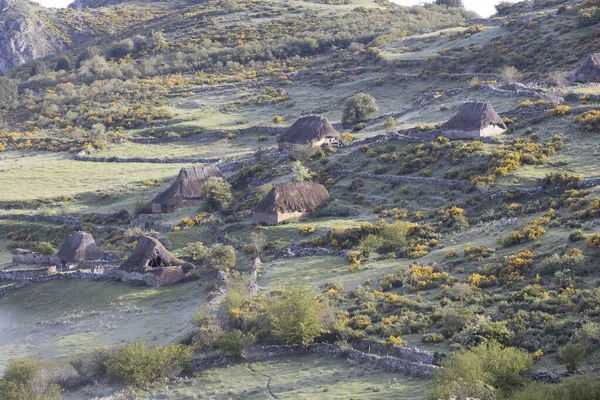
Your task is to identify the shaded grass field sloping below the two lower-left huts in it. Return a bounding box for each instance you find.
[0,281,205,370]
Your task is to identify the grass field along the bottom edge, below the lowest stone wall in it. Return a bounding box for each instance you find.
[65,355,430,400]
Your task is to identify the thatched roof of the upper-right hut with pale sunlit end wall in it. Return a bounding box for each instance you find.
[442,101,506,131]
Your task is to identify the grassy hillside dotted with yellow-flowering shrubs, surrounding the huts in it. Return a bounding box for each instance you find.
[0,0,600,399]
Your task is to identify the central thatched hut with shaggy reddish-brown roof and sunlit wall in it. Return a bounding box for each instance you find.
[253,182,329,225]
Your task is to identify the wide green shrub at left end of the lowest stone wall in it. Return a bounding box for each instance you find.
[106,342,192,387]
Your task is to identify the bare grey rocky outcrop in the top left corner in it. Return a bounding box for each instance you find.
[0,0,67,72]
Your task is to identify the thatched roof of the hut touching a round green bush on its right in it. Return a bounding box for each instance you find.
[152,165,223,206]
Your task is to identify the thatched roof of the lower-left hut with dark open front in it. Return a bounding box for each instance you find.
[119,236,184,272]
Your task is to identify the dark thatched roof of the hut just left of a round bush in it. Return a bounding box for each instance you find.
[279,115,340,144]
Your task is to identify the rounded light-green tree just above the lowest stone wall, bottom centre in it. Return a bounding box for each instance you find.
[267,286,323,344]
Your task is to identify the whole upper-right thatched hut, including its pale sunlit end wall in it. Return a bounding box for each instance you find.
[441,101,506,139]
